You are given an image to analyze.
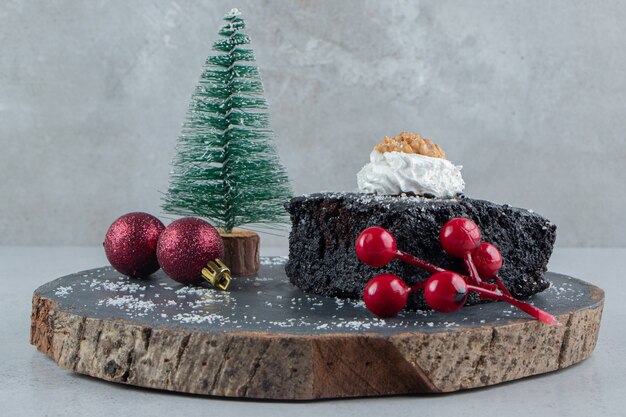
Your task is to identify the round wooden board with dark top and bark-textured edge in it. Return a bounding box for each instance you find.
[30,258,604,400]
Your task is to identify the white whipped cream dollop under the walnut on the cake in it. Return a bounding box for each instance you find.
[356,150,465,198]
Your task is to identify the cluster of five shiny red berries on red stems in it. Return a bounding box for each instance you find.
[356,218,560,326]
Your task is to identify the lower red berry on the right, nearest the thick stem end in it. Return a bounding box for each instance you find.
[424,271,468,313]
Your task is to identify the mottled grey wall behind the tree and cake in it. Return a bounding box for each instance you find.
[0,0,626,246]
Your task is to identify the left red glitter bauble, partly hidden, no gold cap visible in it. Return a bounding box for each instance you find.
[102,212,165,277]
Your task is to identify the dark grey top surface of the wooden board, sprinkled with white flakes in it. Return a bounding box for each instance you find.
[35,258,599,335]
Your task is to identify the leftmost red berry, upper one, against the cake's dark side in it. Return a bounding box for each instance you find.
[355,226,398,267]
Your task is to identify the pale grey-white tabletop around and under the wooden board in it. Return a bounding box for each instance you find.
[0,247,626,417]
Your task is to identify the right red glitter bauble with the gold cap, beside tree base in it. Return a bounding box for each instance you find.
[157,217,224,284]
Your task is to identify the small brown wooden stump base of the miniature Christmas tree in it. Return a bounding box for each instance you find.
[219,229,261,277]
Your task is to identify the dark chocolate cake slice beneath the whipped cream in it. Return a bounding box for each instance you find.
[286,193,556,309]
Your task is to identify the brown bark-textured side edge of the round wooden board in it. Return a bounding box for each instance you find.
[30,288,604,400]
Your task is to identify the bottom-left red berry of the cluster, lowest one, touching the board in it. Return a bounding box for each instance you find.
[363,274,409,317]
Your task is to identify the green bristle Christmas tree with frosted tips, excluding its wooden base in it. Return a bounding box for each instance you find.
[162,9,292,233]
